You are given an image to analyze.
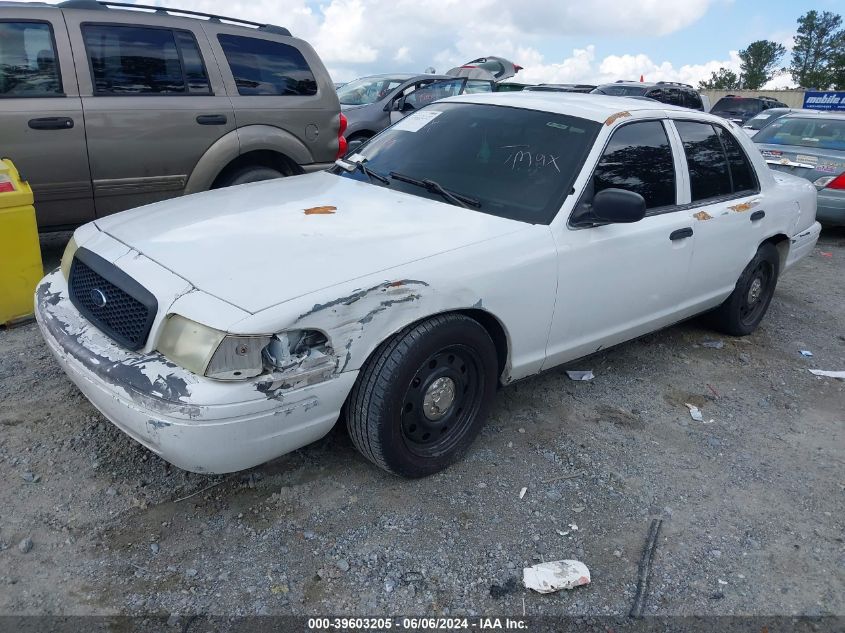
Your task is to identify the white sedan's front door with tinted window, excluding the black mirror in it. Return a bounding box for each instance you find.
[546,121,696,367]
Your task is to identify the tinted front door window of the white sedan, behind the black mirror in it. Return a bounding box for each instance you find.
[593,121,675,209]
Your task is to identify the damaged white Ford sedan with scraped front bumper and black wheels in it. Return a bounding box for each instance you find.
[36,92,819,477]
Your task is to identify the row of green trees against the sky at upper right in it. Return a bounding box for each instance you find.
[698,10,845,90]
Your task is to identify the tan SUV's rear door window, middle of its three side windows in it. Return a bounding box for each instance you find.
[82,24,210,95]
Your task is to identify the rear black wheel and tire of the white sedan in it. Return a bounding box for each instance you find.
[711,243,780,336]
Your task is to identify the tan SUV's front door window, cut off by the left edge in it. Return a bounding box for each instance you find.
[0,22,62,97]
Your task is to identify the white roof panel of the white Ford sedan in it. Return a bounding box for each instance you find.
[438,91,692,123]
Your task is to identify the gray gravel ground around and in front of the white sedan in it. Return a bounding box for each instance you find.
[0,230,845,616]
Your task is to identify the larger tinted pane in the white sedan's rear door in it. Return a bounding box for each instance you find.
[675,121,733,202]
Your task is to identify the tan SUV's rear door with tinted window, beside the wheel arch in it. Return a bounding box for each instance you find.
[65,10,235,217]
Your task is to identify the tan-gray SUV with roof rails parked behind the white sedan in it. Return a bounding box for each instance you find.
[0,0,342,231]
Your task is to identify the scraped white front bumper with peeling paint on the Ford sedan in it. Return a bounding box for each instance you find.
[35,271,358,473]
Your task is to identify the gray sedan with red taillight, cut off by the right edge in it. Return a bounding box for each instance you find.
[754,111,845,226]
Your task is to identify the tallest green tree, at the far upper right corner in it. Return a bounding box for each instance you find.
[789,11,845,89]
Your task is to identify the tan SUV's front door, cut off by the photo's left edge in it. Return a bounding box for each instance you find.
[0,7,94,229]
